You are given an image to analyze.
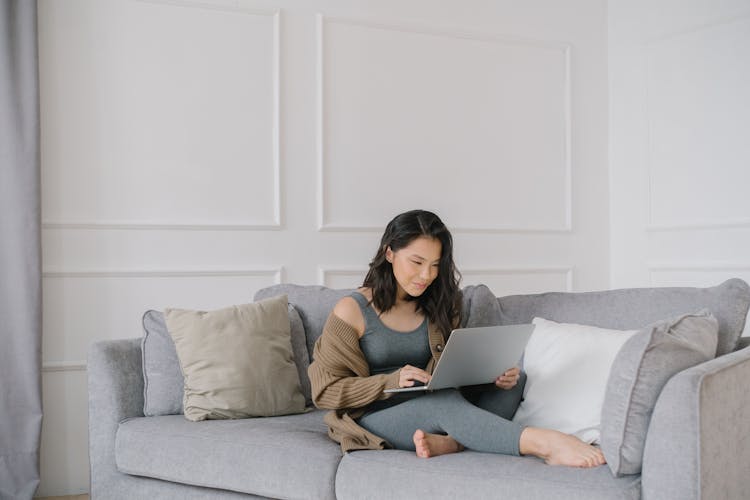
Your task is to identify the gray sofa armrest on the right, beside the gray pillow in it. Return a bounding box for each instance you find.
[641,348,750,500]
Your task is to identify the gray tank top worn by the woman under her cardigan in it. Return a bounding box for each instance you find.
[351,292,432,375]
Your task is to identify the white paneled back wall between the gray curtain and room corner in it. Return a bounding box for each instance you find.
[39,0,612,495]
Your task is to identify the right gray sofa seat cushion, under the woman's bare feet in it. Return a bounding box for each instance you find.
[336,450,641,500]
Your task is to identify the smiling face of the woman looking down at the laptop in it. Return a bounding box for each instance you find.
[385,236,442,298]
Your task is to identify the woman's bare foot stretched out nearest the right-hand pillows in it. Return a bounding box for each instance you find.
[520,427,607,467]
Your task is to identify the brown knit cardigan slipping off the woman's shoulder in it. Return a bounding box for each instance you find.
[308,313,445,453]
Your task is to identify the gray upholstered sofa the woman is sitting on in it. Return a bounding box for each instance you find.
[88,279,750,500]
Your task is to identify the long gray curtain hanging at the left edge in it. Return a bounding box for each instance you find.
[0,0,42,500]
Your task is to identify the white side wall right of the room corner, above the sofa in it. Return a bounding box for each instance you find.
[608,0,750,287]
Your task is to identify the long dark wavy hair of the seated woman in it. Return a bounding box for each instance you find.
[362,210,461,337]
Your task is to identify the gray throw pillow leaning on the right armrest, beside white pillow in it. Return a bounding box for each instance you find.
[601,310,719,476]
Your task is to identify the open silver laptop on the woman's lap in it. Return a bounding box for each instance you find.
[385,325,534,392]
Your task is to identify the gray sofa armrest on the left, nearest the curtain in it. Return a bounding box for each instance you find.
[87,338,143,498]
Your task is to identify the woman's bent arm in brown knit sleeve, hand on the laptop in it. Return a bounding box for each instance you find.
[308,313,401,410]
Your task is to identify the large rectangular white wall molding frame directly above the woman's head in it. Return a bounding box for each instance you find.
[316,13,573,234]
